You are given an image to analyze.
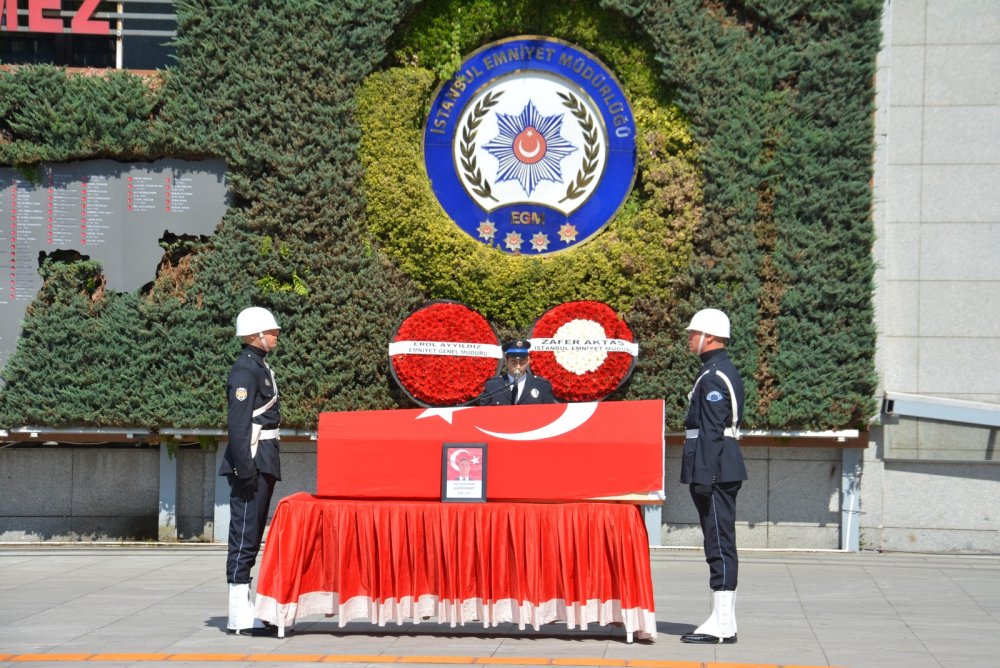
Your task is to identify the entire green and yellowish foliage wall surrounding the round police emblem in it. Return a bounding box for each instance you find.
[0,0,881,429]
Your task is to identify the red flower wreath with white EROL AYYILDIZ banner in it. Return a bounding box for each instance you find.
[389,301,501,407]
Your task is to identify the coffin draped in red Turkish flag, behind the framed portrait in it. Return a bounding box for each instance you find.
[316,400,664,501]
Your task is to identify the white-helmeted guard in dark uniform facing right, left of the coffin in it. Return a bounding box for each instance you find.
[219,306,281,635]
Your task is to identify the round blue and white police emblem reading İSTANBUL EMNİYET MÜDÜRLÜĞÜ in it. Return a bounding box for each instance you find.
[424,37,636,255]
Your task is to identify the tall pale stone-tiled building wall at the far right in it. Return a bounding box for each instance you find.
[861,0,1000,552]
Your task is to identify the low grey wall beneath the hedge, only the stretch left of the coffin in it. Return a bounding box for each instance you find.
[0,443,316,542]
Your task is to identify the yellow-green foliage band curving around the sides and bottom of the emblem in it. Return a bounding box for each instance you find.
[359,68,701,324]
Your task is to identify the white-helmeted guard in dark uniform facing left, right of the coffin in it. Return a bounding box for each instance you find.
[681,309,747,644]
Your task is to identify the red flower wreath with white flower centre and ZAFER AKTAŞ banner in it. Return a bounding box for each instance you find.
[529,301,638,401]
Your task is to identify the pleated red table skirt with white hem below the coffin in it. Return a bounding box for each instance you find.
[256,493,656,639]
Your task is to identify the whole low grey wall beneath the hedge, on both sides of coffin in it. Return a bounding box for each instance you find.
[0,443,841,549]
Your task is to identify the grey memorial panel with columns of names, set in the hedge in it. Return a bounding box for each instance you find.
[0,159,227,370]
